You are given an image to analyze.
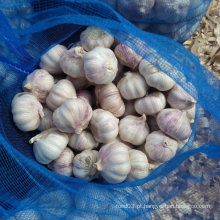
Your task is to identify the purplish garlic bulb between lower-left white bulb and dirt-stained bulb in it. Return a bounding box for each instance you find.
[48,147,74,176]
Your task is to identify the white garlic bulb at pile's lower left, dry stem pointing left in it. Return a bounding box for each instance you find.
[29,128,69,164]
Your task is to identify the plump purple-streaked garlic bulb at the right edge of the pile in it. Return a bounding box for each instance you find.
[157,108,191,141]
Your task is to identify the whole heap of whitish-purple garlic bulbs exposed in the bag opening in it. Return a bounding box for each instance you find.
[12,27,195,183]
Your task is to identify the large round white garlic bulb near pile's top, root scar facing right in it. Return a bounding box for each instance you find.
[84,47,118,84]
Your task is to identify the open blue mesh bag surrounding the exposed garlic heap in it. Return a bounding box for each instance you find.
[0,0,220,220]
